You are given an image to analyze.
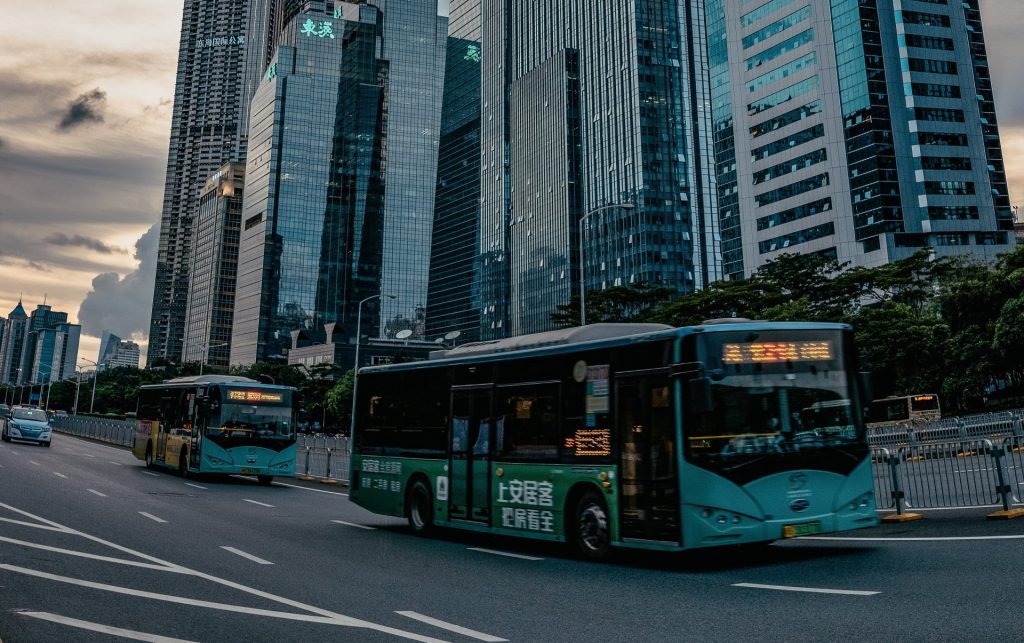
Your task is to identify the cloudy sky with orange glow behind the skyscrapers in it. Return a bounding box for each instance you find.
[0,0,1024,368]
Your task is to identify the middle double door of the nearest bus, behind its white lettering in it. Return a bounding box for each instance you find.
[449,387,494,523]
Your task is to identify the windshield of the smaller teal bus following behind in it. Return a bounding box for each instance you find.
[206,388,295,439]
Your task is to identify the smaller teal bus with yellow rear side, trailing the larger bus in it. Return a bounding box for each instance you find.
[132,375,296,484]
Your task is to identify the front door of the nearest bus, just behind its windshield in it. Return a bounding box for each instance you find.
[615,370,681,543]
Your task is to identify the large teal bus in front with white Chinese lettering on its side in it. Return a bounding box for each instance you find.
[350,320,878,558]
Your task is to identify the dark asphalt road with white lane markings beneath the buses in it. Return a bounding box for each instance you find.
[0,435,1024,643]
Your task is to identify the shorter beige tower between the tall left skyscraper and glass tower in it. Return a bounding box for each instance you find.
[182,163,245,367]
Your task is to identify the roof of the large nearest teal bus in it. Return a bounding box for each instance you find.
[359,319,850,374]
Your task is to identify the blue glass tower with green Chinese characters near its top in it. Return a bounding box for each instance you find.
[229,0,446,365]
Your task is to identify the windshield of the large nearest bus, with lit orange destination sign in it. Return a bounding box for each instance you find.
[684,331,865,483]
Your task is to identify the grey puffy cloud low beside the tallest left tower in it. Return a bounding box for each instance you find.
[78,224,160,337]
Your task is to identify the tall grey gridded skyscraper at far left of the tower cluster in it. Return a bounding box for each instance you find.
[147,0,252,363]
